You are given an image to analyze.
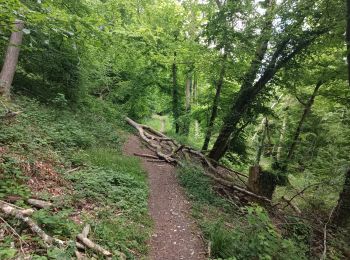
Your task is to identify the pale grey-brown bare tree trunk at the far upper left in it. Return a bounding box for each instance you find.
[0,20,24,98]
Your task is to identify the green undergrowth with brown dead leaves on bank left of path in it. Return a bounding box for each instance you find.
[0,97,151,259]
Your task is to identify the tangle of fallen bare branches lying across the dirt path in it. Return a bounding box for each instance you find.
[125,117,271,204]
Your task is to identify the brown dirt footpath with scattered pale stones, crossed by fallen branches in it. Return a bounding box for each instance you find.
[124,136,206,260]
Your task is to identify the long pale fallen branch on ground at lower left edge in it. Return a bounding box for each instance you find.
[0,202,65,247]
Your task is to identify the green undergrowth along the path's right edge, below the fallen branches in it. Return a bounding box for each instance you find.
[178,165,306,259]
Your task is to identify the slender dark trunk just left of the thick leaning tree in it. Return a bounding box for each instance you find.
[202,53,227,151]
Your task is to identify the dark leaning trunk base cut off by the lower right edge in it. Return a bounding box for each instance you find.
[333,169,350,227]
